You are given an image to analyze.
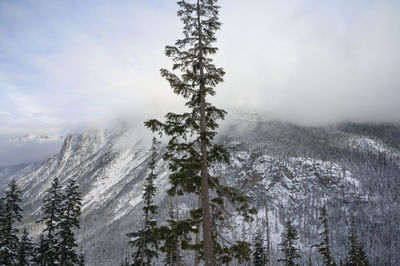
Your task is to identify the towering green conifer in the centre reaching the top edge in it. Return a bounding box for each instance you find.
[145,0,254,266]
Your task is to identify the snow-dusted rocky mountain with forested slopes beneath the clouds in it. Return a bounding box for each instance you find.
[6,120,400,265]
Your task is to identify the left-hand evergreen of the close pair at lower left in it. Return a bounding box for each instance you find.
[37,177,62,265]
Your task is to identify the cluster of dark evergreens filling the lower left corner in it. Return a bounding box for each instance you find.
[0,178,85,266]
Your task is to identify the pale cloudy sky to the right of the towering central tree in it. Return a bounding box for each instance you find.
[218,1,400,125]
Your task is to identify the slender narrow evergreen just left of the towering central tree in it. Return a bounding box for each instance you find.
[128,138,159,266]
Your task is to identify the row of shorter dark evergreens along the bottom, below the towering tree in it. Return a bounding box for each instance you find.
[0,177,370,266]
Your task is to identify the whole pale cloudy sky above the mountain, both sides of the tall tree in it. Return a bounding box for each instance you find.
[0,0,400,140]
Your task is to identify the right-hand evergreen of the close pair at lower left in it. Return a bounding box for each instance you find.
[57,179,82,265]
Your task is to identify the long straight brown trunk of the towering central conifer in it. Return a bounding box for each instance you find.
[197,0,214,266]
